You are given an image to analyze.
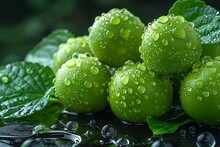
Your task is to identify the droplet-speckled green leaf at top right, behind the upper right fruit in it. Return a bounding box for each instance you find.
[169,0,220,44]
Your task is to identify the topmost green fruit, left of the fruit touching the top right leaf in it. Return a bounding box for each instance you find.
[89,9,144,67]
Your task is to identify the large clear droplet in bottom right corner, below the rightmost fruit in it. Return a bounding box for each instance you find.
[196,132,216,147]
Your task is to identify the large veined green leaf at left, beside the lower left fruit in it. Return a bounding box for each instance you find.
[0,62,61,124]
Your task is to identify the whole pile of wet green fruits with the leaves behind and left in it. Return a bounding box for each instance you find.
[0,0,220,136]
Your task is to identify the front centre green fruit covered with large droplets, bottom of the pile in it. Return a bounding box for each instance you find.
[108,64,173,123]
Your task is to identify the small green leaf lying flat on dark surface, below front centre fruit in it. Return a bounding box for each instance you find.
[147,113,192,135]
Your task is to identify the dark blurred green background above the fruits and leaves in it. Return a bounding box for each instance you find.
[0,0,220,65]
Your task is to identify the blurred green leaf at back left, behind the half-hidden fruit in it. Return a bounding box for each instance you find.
[25,29,73,68]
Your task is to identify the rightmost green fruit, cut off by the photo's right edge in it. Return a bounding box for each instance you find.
[180,56,220,125]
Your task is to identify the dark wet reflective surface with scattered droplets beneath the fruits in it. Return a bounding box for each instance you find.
[0,110,220,147]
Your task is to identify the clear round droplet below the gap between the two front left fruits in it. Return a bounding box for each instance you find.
[101,124,117,139]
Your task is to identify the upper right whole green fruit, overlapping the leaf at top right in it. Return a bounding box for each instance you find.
[139,15,202,75]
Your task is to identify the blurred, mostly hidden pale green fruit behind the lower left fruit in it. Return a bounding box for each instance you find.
[53,36,91,72]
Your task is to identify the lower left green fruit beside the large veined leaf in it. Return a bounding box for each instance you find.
[55,54,111,113]
